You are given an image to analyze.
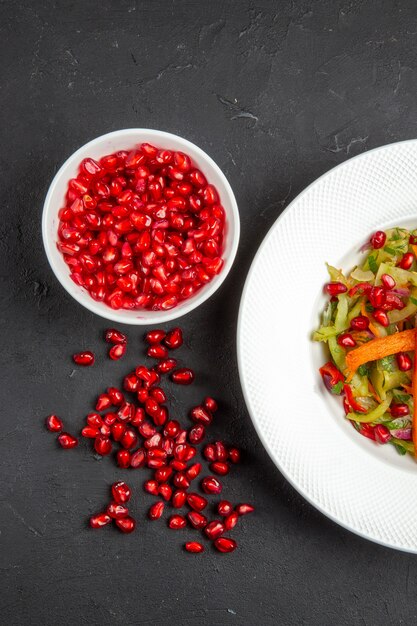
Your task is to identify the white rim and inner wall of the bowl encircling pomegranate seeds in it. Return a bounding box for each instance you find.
[42,128,240,326]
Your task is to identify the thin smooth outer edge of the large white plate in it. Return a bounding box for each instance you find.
[236,138,417,554]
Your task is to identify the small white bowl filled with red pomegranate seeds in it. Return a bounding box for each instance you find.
[42,129,240,324]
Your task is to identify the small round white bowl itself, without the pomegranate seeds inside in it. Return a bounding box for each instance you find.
[42,128,240,324]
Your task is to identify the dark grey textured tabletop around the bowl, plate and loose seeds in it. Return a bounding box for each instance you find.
[0,0,417,626]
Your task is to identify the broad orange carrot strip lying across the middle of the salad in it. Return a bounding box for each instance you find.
[346,329,417,378]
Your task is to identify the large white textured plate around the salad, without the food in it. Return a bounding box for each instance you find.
[237,140,417,552]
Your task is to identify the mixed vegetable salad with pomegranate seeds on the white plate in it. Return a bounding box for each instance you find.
[313,227,417,456]
